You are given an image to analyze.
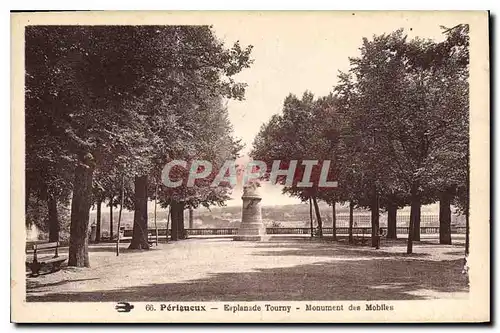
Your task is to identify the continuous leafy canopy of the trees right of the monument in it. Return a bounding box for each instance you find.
[252,25,469,249]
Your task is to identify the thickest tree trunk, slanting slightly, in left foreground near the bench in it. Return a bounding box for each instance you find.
[68,154,95,267]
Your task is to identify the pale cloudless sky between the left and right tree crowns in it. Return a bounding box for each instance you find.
[209,12,463,205]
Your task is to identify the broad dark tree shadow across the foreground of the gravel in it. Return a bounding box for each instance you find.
[27,257,468,302]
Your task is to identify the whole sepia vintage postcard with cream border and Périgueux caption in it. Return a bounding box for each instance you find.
[11,11,490,323]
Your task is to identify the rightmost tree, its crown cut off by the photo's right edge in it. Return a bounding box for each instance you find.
[429,24,469,247]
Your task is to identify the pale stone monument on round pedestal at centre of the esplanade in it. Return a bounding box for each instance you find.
[233,182,266,241]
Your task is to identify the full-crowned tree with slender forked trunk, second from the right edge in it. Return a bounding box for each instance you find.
[340,30,468,253]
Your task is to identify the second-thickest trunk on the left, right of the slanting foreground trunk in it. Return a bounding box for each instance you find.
[128,176,149,250]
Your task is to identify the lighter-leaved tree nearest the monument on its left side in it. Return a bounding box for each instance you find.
[130,27,252,244]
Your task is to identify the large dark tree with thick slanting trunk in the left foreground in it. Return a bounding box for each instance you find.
[26,26,177,266]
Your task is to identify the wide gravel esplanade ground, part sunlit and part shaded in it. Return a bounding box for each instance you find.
[27,237,468,301]
